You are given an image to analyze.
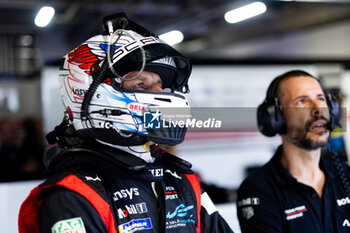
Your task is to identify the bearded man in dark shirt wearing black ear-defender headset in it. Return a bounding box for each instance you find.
[237,70,350,233]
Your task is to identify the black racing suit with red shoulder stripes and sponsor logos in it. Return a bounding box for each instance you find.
[19,142,232,233]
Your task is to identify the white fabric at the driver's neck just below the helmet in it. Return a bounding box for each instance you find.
[96,139,155,163]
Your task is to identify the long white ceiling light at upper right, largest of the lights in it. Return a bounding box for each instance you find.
[225,2,266,23]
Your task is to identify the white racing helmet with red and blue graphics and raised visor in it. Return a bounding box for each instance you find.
[56,13,191,146]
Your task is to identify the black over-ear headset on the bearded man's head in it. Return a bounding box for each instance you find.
[257,70,340,137]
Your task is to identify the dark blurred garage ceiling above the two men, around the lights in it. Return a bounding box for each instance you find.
[0,0,350,73]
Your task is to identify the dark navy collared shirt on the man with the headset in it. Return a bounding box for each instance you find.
[237,146,350,233]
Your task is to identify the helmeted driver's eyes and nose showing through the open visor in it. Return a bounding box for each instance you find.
[122,71,163,92]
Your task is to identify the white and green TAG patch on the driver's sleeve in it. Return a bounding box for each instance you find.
[51,217,86,233]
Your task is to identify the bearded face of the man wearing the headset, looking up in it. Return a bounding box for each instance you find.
[279,76,329,150]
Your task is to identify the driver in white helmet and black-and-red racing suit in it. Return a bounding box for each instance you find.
[19,13,232,233]
